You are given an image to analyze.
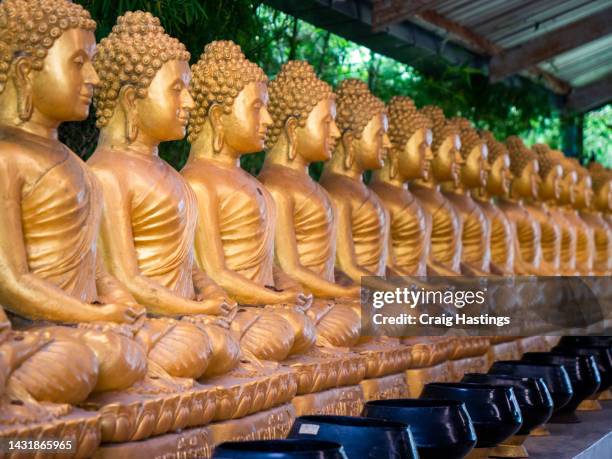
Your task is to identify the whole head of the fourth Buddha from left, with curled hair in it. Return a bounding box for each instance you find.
[266,61,340,164]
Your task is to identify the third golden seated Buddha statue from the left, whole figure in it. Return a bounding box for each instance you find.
[181,41,358,393]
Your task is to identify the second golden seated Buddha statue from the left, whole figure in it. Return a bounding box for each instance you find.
[88,12,294,419]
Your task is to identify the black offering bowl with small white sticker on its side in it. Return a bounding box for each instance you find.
[289,416,419,459]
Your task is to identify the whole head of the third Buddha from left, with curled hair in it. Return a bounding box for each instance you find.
[187,41,272,157]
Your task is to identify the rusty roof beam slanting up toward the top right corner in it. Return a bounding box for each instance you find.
[489,7,612,82]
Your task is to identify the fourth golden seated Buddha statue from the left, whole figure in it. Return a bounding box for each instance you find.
[259,61,404,399]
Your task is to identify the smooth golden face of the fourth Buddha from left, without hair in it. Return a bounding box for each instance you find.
[296,97,340,163]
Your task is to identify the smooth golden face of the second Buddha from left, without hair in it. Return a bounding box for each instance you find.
[135,60,194,143]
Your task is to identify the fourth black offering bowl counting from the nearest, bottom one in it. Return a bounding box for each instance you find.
[420,382,523,448]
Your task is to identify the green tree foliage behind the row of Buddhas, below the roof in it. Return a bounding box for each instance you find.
[60,0,611,178]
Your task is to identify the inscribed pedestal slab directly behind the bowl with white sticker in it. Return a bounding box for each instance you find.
[291,386,364,416]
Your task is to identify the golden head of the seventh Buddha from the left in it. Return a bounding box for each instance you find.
[421,105,463,186]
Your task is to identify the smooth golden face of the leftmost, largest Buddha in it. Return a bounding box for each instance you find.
[31,29,100,122]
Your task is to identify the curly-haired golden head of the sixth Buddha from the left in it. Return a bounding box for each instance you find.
[385,96,433,182]
